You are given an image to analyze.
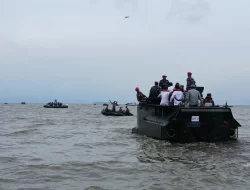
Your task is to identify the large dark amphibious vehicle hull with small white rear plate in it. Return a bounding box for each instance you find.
[132,87,241,142]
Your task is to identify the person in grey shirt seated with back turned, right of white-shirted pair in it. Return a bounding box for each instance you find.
[186,85,202,107]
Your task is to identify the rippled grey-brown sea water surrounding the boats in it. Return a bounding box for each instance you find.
[0,104,250,190]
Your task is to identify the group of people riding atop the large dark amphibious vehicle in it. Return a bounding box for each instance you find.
[135,72,214,107]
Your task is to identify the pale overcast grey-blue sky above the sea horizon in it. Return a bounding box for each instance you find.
[0,0,250,105]
